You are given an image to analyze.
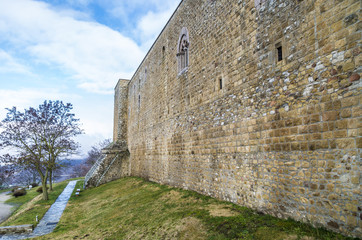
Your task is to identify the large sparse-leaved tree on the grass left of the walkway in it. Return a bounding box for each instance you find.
[0,101,82,200]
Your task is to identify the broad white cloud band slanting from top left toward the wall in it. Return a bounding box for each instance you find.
[0,0,144,92]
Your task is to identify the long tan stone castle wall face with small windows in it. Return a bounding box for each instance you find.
[116,0,362,237]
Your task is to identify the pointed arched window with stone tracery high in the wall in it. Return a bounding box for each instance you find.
[176,27,190,73]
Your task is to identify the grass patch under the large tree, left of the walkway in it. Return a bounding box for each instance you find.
[0,180,81,229]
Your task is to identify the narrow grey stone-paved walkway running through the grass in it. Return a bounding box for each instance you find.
[0,181,77,240]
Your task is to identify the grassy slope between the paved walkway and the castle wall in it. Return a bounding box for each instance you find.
[39,178,356,240]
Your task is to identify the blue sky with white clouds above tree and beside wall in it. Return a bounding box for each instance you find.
[0,0,181,157]
